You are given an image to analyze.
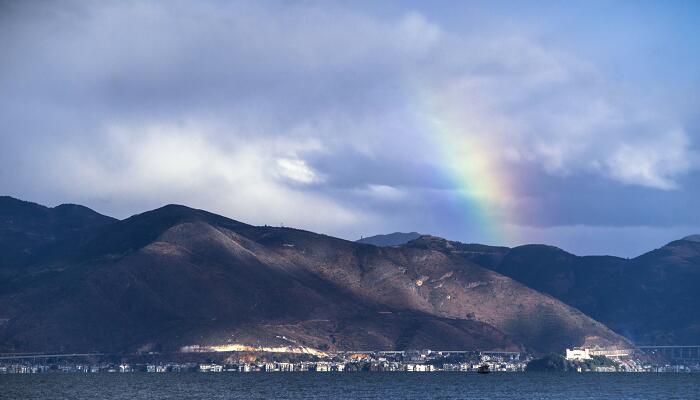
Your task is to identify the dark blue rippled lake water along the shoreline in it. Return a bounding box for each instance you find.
[0,372,700,400]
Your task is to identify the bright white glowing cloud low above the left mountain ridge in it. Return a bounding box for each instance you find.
[46,123,360,230]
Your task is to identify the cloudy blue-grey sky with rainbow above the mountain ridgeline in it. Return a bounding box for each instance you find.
[0,0,700,257]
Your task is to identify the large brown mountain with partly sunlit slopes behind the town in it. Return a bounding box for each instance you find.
[0,197,629,352]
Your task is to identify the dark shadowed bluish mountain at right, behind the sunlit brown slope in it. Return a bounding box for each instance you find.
[452,235,700,345]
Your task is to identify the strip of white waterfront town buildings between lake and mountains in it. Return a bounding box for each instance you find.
[0,349,700,374]
